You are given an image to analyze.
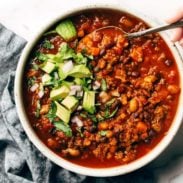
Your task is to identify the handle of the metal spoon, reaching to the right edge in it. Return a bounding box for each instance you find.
[127,21,183,38]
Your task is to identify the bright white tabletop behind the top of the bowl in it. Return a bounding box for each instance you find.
[0,0,183,40]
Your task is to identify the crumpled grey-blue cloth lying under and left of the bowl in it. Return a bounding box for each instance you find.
[0,24,183,183]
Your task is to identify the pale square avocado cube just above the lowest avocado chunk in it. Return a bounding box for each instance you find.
[62,96,78,111]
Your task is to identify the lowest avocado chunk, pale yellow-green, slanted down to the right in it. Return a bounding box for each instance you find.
[55,101,71,123]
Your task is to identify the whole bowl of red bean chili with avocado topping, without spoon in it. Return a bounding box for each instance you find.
[15,5,183,177]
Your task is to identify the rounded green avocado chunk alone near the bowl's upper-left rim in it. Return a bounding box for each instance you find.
[56,19,77,41]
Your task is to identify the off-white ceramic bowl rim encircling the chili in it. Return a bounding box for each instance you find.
[15,5,183,177]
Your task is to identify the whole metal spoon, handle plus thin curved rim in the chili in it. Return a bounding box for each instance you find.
[94,21,183,39]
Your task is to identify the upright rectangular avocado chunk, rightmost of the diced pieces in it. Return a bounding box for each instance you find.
[83,91,95,114]
